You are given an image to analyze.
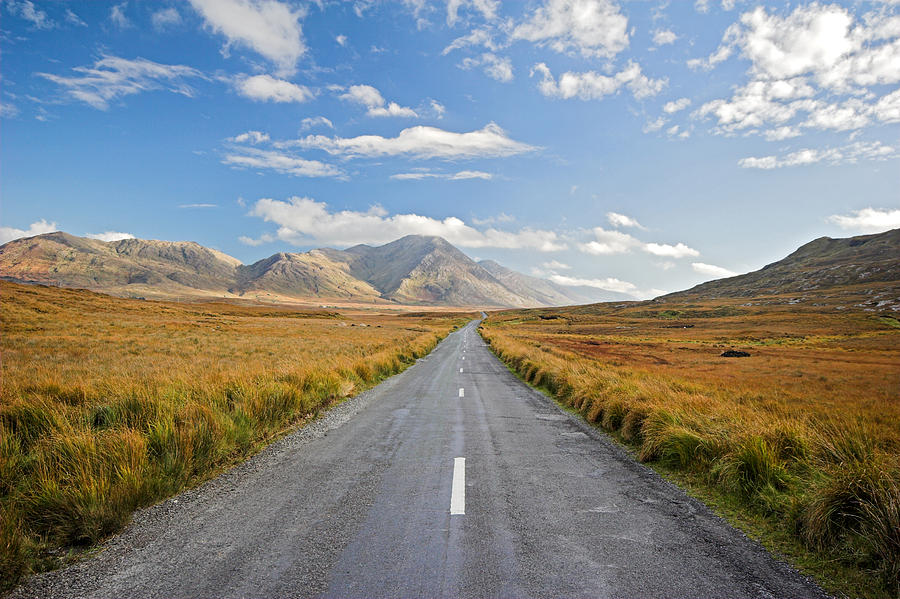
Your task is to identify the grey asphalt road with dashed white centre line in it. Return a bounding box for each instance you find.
[13,322,825,598]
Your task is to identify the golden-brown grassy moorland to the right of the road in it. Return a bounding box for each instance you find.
[482,300,900,597]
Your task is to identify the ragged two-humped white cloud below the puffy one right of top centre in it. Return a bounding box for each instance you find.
[531,61,668,100]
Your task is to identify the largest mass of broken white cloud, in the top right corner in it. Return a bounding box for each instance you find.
[689,2,900,145]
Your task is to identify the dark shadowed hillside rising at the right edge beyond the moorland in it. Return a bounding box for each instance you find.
[660,229,900,299]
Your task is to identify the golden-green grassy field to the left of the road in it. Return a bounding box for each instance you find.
[0,283,468,589]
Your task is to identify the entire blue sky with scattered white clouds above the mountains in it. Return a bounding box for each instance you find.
[0,0,900,298]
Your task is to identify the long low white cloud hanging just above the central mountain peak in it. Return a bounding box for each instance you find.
[244,197,566,252]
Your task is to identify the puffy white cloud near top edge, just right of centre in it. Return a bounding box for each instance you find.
[511,0,628,58]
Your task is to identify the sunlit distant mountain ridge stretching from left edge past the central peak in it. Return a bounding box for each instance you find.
[0,232,595,308]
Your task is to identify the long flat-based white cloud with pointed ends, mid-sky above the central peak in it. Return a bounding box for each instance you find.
[292,123,538,159]
